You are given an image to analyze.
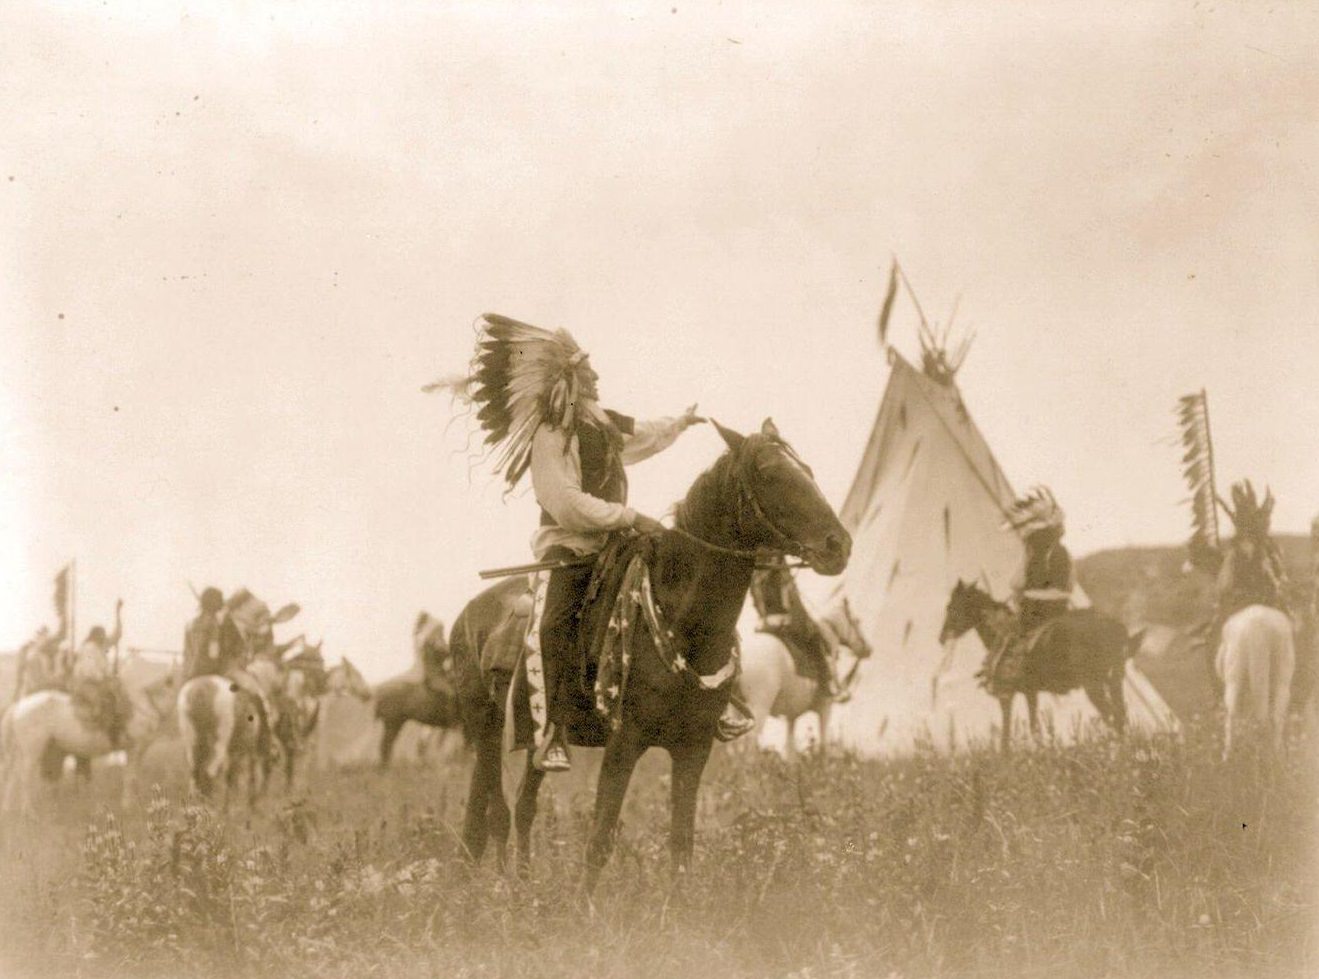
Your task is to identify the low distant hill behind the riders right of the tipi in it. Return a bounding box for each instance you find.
[1076,534,1315,720]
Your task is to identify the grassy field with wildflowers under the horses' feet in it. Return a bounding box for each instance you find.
[0,732,1319,979]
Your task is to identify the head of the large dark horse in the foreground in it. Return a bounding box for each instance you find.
[715,418,852,575]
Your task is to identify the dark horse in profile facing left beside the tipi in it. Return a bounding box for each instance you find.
[939,579,1140,751]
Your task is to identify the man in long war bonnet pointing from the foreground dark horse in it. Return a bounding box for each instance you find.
[427,313,704,772]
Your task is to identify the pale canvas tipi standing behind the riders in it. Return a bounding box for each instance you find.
[835,348,1174,752]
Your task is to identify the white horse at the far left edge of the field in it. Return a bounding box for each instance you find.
[0,677,174,813]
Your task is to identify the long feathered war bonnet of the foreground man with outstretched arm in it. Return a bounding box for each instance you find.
[422,313,594,487]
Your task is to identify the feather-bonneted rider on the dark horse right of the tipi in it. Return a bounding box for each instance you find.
[979,486,1076,686]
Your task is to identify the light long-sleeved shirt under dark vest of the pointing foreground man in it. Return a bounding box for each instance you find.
[532,418,682,561]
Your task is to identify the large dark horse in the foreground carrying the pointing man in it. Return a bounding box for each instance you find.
[451,420,852,892]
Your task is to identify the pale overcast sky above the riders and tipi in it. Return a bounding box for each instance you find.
[0,0,1319,677]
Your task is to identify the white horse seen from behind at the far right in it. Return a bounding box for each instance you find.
[1215,606,1297,760]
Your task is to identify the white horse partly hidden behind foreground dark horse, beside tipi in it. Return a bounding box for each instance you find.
[737,598,871,757]
